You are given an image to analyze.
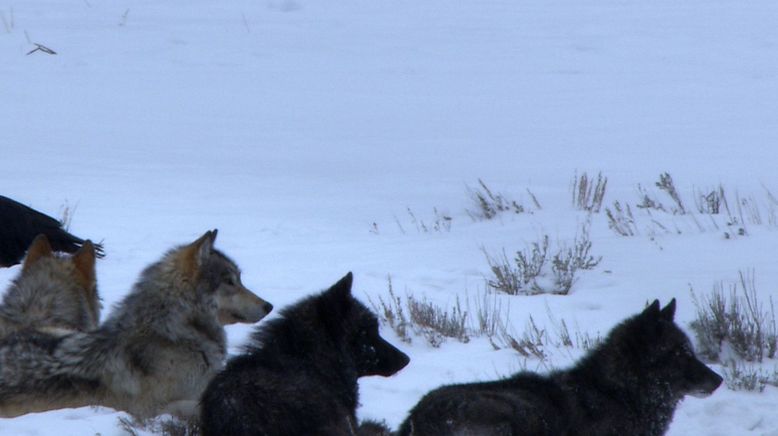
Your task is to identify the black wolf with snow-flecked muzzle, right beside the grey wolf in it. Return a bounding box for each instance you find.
[201,273,409,436]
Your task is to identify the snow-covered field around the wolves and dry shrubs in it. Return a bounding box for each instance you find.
[0,0,778,436]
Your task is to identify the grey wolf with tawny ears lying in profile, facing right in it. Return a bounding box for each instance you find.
[0,230,272,420]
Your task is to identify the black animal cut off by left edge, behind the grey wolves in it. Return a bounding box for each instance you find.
[0,195,103,267]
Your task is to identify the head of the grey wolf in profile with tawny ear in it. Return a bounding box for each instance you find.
[174,230,273,325]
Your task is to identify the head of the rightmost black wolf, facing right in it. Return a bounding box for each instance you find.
[603,299,722,399]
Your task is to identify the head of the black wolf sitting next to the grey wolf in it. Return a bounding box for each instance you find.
[315,273,410,377]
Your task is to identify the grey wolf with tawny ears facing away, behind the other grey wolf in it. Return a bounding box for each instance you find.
[0,234,102,337]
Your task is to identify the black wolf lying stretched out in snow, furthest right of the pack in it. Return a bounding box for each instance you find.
[399,299,722,436]
